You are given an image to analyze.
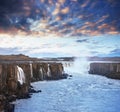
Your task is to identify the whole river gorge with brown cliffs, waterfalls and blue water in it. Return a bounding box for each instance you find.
[0,55,120,112]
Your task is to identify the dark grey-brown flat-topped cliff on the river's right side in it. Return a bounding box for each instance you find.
[89,63,120,79]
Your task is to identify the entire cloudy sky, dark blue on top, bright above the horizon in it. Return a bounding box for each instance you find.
[0,0,120,57]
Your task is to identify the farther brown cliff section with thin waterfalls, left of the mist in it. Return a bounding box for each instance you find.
[32,63,67,81]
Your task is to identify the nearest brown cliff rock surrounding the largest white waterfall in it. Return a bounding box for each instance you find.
[0,64,30,112]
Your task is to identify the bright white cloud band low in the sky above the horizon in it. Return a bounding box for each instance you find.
[0,35,120,57]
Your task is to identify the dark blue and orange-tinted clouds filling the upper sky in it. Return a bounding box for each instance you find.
[0,0,120,36]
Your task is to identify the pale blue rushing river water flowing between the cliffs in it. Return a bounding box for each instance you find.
[15,59,120,112]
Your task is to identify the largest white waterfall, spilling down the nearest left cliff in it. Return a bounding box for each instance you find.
[17,66,25,85]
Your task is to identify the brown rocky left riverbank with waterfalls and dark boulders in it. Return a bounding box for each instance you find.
[0,56,67,112]
